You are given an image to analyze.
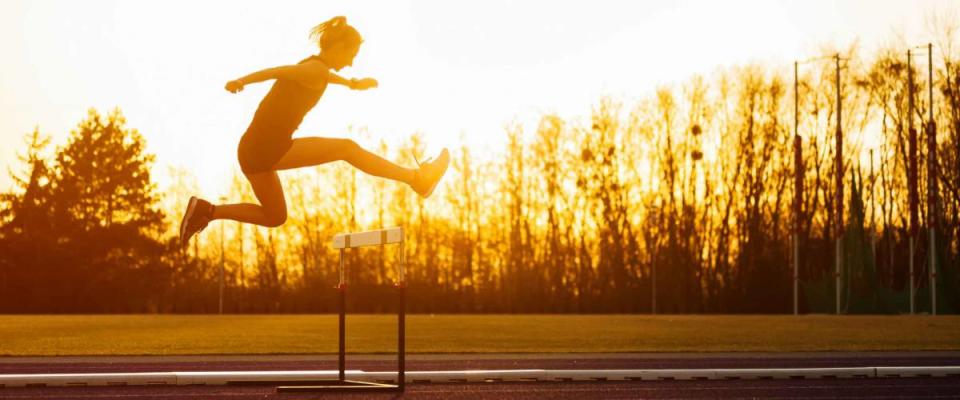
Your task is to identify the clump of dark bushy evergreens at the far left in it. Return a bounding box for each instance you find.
[0,109,169,312]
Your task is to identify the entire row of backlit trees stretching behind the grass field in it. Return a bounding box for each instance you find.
[0,30,960,313]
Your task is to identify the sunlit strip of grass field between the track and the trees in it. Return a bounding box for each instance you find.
[0,315,960,356]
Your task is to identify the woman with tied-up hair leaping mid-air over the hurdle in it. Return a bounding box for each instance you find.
[180,17,450,244]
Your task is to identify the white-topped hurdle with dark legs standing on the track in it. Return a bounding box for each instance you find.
[276,227,407,393]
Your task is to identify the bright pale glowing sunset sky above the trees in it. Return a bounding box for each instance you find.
[0,0,957,196]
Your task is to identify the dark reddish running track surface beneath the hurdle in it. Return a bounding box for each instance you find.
[0,352,960,399]
